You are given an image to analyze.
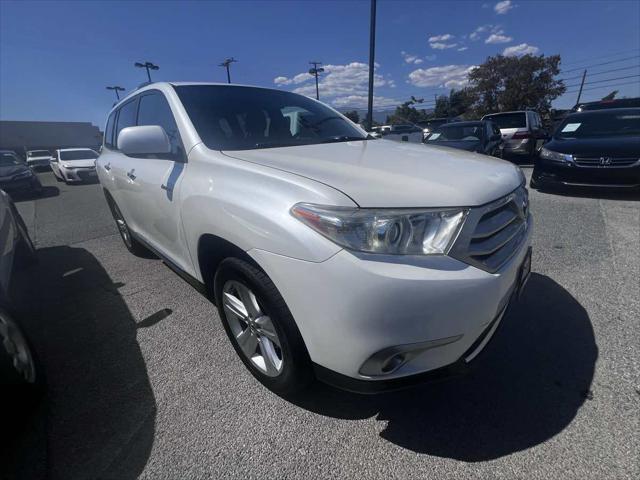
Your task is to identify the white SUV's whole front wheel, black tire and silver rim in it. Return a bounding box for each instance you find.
[214,258,314,395]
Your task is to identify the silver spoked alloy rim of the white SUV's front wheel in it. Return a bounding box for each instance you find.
[222,280,283,377]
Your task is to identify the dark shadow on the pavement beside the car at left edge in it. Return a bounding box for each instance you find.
[11,246,156,479]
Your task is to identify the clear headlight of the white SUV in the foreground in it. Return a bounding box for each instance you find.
[291,203,468,255]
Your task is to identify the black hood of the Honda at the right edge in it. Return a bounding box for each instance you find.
[544,135,640,158]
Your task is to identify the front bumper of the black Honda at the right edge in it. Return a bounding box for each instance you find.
[532,159,640,188]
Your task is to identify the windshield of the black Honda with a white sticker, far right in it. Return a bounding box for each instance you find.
[555,108,640,138]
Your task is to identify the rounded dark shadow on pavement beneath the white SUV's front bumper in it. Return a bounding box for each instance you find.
[291,274,598,462]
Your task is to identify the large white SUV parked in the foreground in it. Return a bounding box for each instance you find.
[96,83,532,393]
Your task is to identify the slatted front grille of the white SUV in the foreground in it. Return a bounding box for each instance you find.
[449,185,530,272]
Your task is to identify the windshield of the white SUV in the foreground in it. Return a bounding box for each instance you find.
[176,85,367,150]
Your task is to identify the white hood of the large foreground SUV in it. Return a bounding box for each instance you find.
[223,140,521,207]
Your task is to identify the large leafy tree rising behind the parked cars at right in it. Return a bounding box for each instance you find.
[469,55,566,116]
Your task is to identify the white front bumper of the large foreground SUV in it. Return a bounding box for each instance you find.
[249,222,533,389]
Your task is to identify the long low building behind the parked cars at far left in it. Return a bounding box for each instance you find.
[0,120,102,156]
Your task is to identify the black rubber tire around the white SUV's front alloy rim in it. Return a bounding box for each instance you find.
[213,258,314,395]
